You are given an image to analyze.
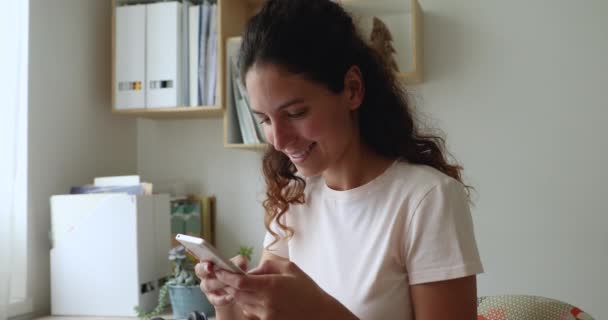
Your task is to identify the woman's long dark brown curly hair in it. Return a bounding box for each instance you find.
[239,0,462,242]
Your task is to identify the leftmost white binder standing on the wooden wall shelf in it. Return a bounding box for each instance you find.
[114,5,146,109]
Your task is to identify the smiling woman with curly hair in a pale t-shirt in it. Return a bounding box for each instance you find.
[196,0,483,320]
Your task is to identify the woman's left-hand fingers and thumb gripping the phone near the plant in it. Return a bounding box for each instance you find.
[194,256,247,307]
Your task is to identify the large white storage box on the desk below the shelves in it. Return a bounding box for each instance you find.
[51,193,171,316]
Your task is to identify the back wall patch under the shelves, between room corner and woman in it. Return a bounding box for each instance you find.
[137,119,265,264]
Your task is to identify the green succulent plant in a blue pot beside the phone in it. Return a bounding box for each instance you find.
[135,246,253,319]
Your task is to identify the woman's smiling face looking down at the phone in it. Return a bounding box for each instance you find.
[245,64,362,176]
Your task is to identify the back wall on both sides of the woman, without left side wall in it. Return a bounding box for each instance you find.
[138,0,608,319]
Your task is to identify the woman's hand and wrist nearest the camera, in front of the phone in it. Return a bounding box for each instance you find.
[216,260,356,320]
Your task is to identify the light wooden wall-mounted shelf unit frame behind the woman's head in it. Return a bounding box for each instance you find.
[111,0,423,150]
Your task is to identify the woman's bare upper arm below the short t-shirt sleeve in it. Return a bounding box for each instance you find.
[410,276,477,320]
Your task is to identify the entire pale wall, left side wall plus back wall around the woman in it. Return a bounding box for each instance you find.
[28,0,608,319]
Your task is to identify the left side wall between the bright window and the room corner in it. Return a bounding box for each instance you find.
[27,0,136,315]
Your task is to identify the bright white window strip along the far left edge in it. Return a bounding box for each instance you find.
[0,1,32,320]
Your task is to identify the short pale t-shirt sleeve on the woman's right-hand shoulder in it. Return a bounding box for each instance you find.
[404,179,483,285]
